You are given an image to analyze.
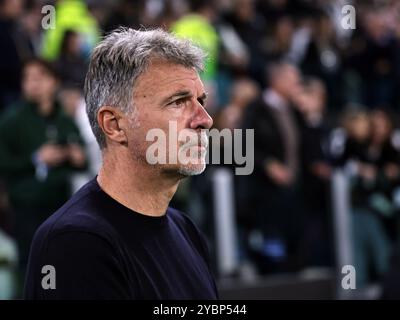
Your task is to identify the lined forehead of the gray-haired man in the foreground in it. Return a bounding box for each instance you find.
[135,61,204,95]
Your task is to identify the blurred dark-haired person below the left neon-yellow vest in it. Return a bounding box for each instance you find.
[55,30,87,88]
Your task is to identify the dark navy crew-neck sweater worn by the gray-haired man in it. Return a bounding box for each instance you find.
[25,179,217,299]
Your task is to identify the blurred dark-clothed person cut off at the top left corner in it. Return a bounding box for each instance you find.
[0,0,33,112]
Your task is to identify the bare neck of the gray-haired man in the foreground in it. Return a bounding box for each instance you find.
[97,151,179,216]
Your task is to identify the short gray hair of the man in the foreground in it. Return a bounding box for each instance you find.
[84,28,205,149]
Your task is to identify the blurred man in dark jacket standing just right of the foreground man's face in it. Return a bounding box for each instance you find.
[244,61,301,273]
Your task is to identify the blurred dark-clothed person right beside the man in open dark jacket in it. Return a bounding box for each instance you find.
[296,78,334,266]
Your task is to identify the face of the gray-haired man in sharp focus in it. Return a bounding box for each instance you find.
[127,61,212,176]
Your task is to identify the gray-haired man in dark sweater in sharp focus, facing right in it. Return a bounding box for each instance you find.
[25,29,217,299]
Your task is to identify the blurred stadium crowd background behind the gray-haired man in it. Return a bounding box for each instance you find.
[0,0,400,299]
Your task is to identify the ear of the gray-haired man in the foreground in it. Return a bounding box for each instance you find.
[97,106,128,144]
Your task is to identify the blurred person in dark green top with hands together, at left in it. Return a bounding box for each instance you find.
[0,59,86,290]
